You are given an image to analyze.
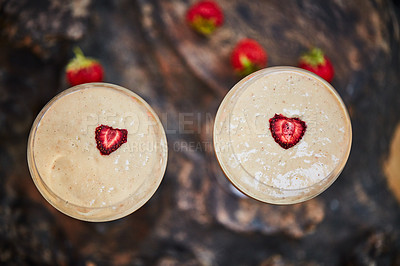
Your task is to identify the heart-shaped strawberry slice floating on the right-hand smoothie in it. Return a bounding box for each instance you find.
[269,114,307,149]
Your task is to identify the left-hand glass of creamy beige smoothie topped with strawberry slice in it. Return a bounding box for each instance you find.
[27,83,168,222]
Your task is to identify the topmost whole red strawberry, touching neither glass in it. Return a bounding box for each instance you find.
[186,0,224,36]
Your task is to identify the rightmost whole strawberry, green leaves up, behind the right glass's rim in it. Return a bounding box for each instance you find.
[299,48,335,82]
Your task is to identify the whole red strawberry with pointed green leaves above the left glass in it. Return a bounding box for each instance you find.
[65,48,104,86]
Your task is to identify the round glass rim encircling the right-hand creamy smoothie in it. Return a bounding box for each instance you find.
[213,66,352,205]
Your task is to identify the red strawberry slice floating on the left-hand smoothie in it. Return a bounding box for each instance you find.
[95,125,128,155]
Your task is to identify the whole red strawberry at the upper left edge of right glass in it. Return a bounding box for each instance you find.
[231,38,268,76]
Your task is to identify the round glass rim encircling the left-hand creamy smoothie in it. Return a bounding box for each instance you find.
[27,82,168,222]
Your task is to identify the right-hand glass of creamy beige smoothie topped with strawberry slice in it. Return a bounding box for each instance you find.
[213,67,352,204]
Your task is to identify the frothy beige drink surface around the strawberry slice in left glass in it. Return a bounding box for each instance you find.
[33,86,165,207]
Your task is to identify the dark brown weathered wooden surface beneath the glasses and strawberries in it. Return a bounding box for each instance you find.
[0,0,400,265]
